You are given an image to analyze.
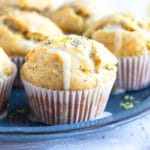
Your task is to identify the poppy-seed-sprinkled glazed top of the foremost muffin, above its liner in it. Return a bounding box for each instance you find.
[21,35,117,90]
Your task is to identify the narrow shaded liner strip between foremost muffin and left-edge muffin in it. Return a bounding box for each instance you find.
[11,56,25,88]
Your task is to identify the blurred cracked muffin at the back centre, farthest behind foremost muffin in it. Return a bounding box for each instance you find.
[51,0,114,35]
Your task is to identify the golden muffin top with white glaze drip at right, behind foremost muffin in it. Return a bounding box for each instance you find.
[84,15,150,57]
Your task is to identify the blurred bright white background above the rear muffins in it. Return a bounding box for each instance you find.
[53,0,150,16]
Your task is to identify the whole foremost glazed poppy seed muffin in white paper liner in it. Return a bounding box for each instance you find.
[21,35,117,124]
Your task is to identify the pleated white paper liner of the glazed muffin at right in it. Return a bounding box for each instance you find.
[115,55,150,91]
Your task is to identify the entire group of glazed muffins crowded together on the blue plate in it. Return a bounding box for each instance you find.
[0,0,150,124]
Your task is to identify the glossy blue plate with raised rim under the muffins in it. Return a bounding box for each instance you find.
[0,87,150,142]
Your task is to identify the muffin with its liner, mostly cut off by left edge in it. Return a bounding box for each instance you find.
[0,48,16,118]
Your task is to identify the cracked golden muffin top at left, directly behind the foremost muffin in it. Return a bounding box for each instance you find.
[0,9,63,56]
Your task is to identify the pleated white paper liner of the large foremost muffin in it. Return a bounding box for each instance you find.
[22,77,116,125]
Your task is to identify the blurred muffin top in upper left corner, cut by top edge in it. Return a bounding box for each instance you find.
[0,0,52,12]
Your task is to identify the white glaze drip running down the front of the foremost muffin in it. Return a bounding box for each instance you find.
[47,49,71,90]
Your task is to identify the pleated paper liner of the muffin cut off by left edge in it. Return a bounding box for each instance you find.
[0,64,17,115]
